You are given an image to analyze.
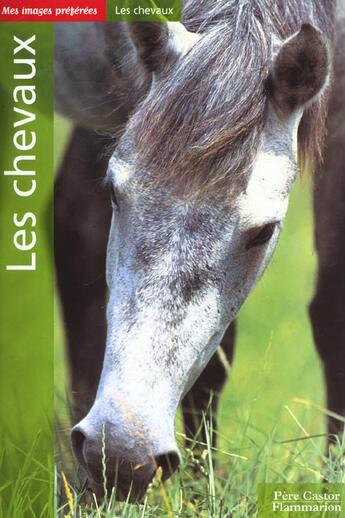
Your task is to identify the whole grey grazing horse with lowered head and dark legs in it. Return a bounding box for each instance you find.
[55,0,345,500]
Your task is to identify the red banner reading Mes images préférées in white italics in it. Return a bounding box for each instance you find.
[0,0,106,22]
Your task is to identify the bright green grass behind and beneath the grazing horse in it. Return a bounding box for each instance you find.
[52,119,345,518]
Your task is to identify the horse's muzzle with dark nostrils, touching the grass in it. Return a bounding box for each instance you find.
[71,406,179,502]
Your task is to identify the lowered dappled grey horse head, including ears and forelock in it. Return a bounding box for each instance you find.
[72,17,330,500]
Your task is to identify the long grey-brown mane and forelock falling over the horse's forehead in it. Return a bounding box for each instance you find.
[125,0,335,199]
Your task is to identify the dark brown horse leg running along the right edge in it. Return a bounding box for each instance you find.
[310,12,345,439]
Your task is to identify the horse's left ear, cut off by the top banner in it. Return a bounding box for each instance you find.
[128,22,199,74]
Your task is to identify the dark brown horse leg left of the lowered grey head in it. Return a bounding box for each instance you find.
[54,129,111,420]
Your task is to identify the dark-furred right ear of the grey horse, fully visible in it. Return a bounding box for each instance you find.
[270,23,330,115]
